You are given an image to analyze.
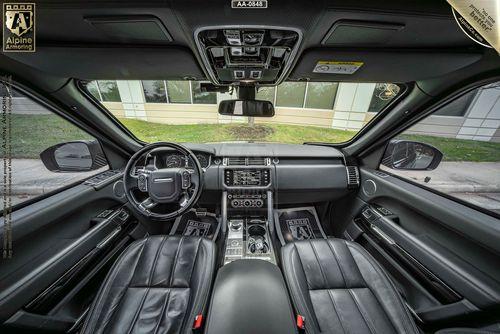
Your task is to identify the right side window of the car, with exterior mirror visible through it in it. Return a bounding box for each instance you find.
[380,83,500,214]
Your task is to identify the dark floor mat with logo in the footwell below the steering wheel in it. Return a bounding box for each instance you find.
[170,209,220,241]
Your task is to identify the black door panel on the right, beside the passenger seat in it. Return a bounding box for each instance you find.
[347,168,500,322]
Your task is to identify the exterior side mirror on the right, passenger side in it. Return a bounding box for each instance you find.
[382,140,443,170]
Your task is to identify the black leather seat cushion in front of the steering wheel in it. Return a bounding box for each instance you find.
[82,236,215,334]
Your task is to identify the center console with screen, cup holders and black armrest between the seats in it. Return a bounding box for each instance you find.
[205,157,297,334]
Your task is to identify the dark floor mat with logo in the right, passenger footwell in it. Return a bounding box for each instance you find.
[274,206,326,246]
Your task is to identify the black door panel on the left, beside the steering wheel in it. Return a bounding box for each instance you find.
[0,174,136,331]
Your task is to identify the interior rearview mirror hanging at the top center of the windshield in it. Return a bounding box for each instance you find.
[219,100,274,117]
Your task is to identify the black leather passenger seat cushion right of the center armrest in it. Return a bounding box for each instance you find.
[281,239,419,334]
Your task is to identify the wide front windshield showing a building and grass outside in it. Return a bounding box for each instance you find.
[87,80,401,144]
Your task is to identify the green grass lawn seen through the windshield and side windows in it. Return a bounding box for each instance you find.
[4,115,500,161]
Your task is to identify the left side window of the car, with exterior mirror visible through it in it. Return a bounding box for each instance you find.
[0,87,108,209]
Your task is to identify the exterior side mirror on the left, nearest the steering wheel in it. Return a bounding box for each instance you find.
[40,140,107,172]
